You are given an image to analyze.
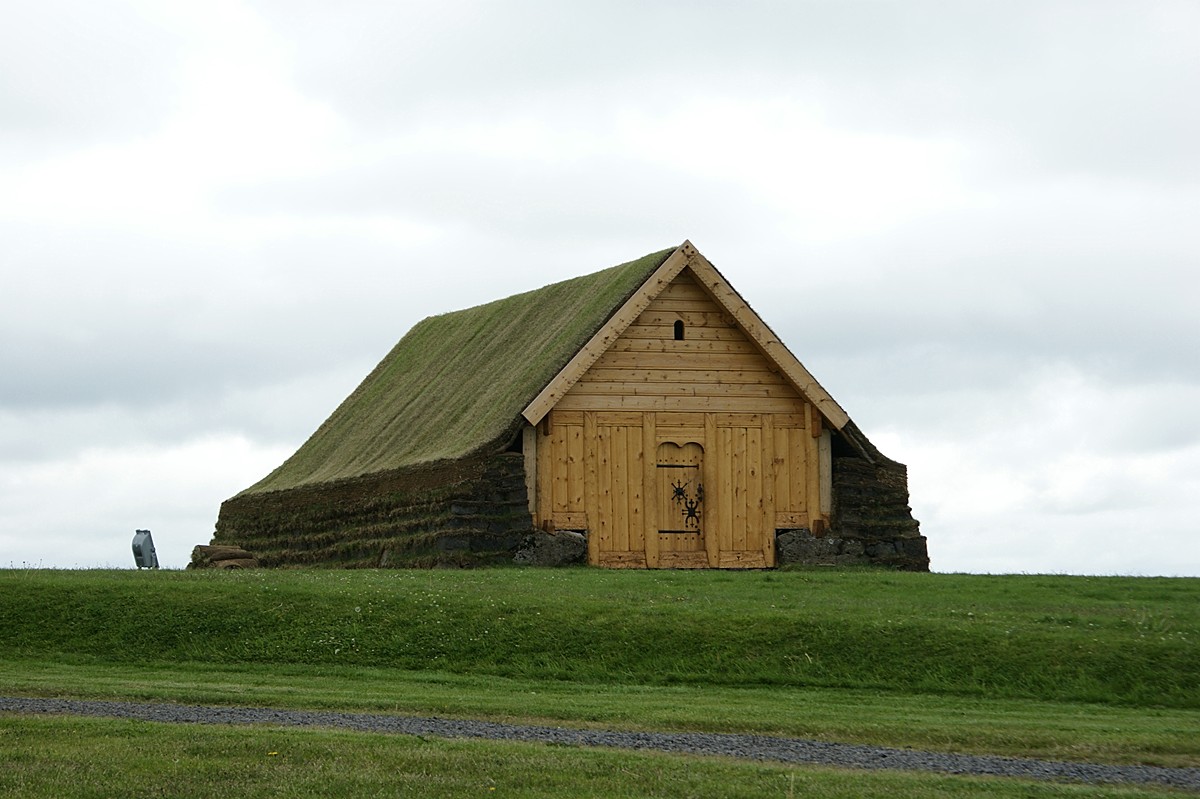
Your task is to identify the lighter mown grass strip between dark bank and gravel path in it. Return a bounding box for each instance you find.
[0,655,1200,768]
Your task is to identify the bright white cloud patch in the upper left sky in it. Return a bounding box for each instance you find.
[0,2,343,226]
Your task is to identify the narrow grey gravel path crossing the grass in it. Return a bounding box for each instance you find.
[0,697,1200,791]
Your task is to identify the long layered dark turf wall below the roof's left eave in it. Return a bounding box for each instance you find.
[212,452,533,567]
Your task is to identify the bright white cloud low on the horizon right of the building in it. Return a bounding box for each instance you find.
[875,368,1200,575]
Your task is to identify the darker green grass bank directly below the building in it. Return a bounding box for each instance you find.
[0,569,1200,709]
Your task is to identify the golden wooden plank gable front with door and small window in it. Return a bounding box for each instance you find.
[523,244,848,569]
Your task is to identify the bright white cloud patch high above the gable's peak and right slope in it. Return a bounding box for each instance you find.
[612,95,965,239]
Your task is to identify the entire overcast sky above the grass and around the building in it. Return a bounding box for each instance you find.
[0,0,1200,576]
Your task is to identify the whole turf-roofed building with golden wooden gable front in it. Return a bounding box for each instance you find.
[212,242,929,570]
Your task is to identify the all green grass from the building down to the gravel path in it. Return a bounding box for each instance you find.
[0,569,1200,795]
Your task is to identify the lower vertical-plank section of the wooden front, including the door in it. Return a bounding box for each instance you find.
[538,411,805,569]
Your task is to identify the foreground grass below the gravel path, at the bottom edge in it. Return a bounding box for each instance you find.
[0,716,1184,799]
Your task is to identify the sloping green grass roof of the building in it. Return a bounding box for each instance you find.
[242,247,674,494]
